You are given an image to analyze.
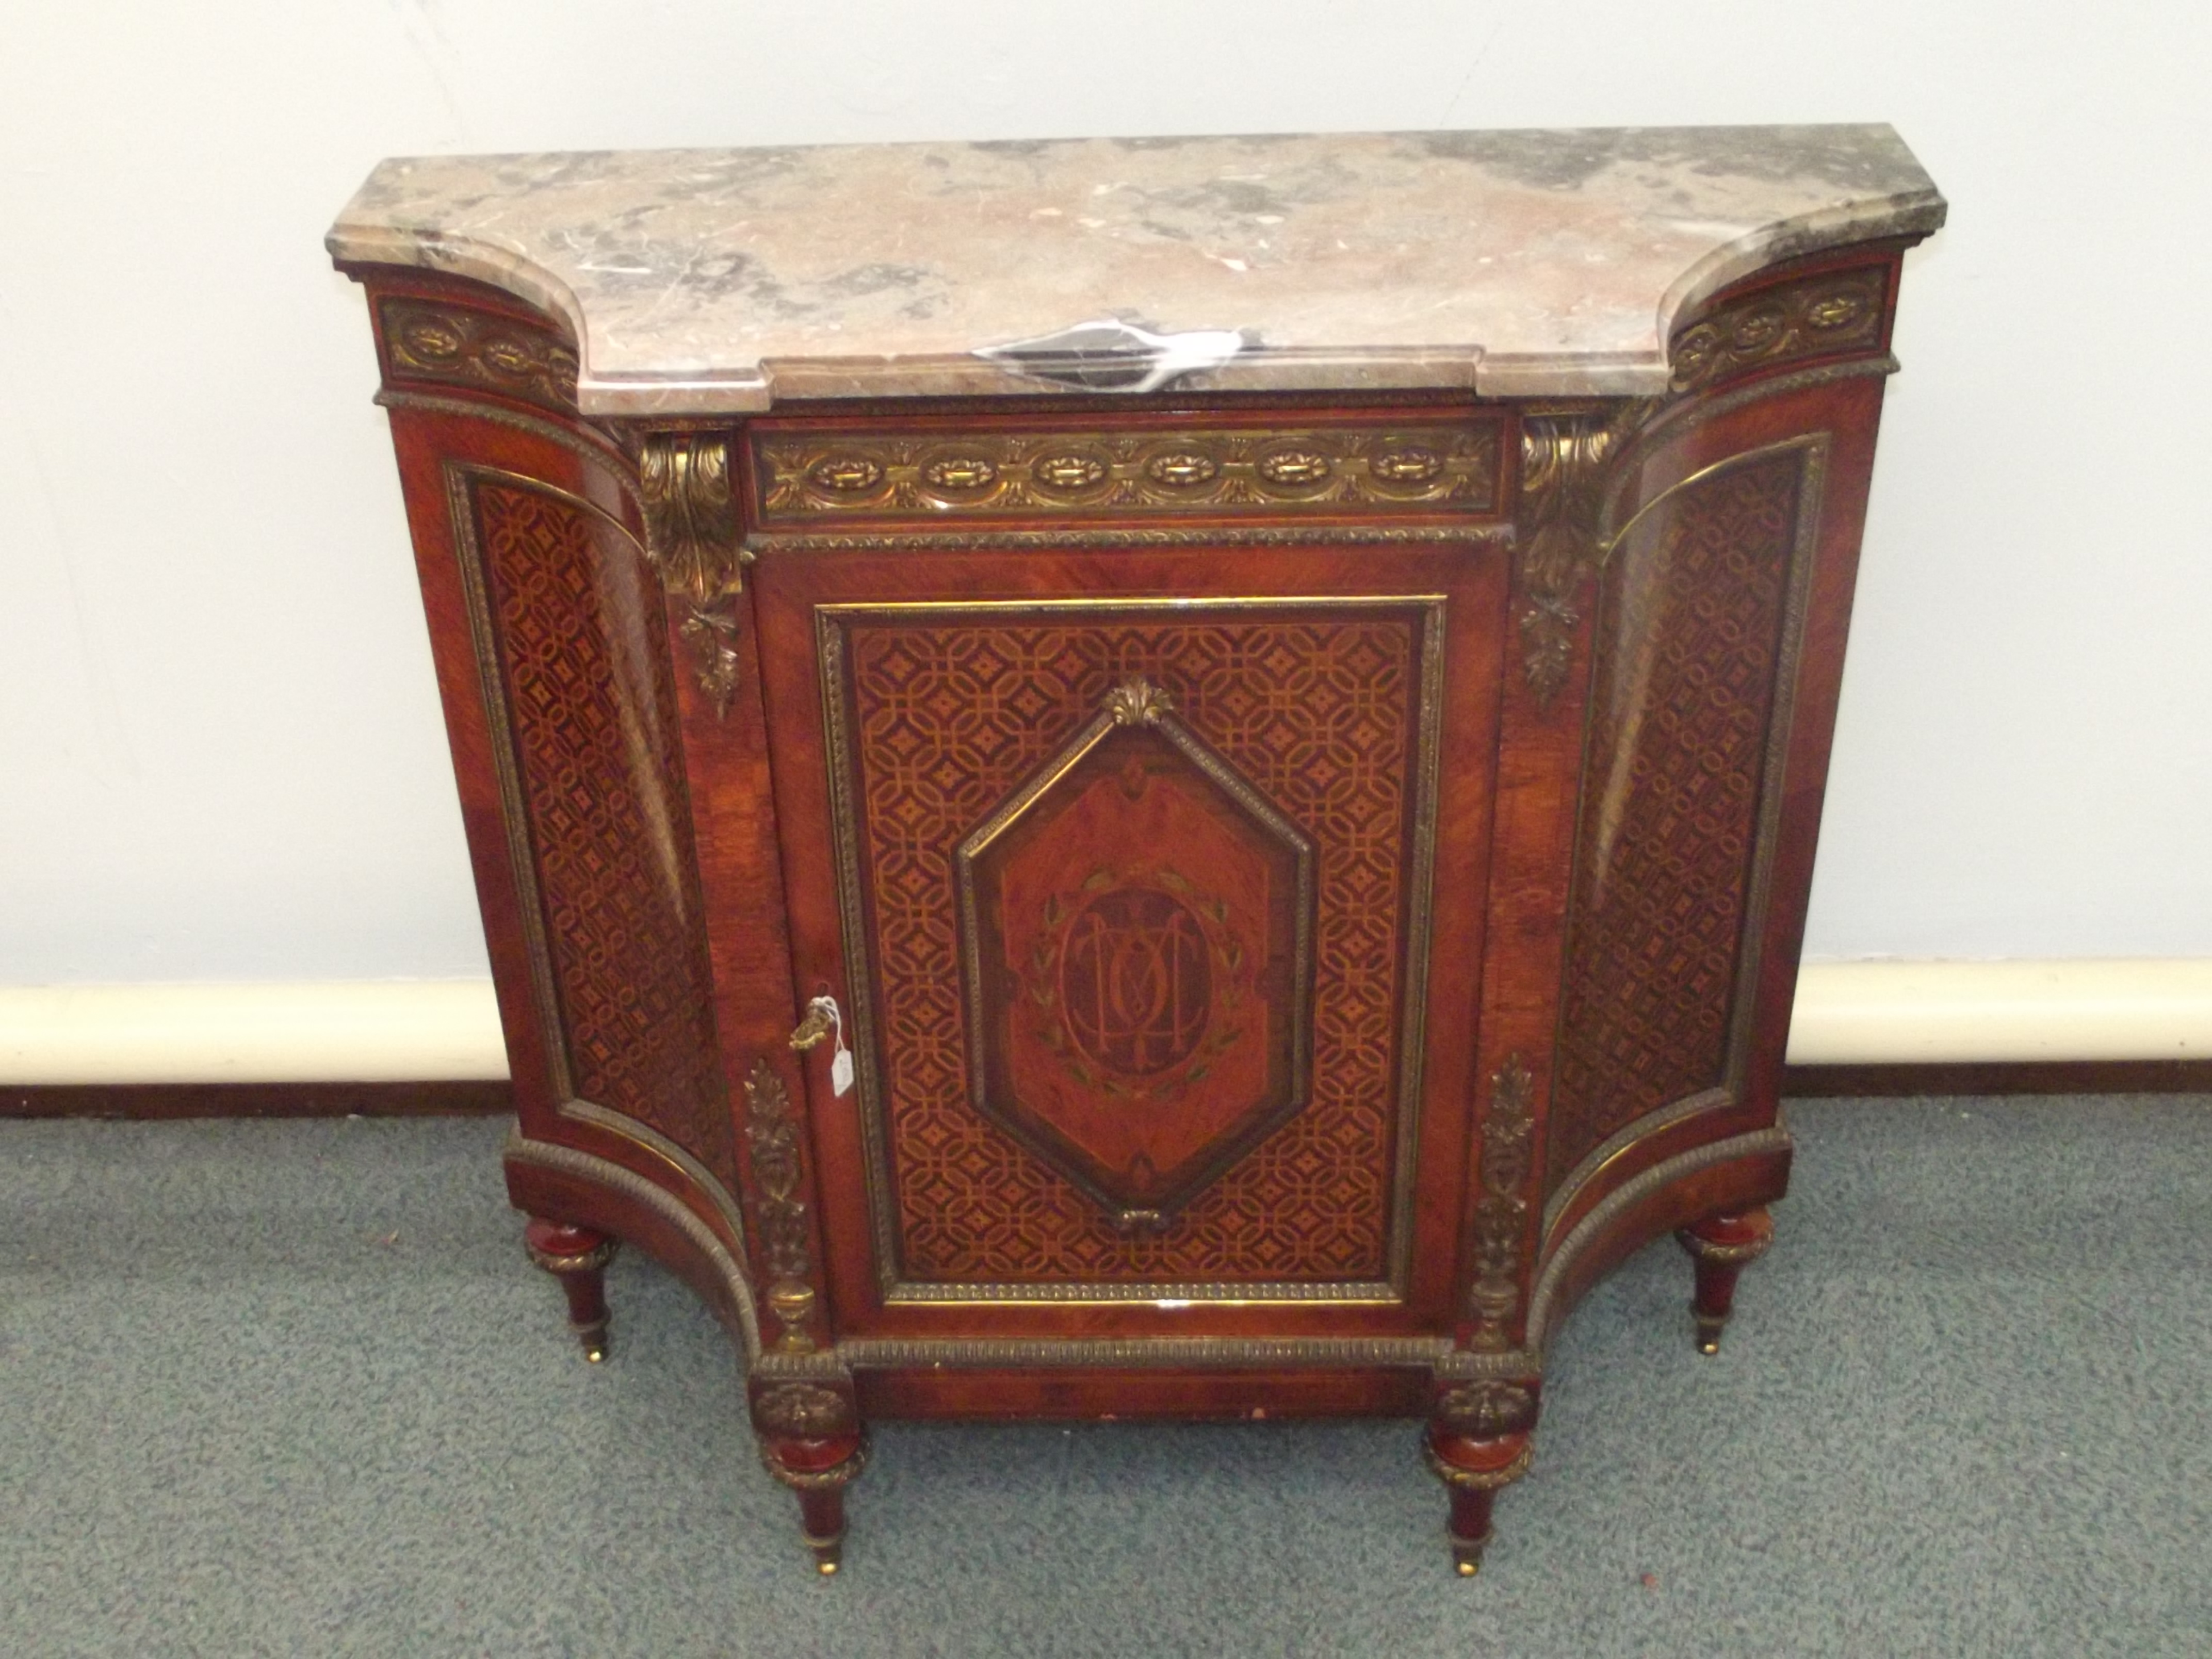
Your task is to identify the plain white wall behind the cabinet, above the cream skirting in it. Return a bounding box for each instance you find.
[0,0,2212,984]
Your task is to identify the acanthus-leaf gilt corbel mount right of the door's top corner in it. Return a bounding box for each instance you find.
[1520,413,1654,708]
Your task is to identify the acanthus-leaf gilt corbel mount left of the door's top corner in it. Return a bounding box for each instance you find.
[637,431,752,714]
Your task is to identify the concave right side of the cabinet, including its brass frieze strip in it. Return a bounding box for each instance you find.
[1544,248,1898,1274]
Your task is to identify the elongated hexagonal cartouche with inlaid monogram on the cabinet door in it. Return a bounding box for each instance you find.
[955,679,1314,1230]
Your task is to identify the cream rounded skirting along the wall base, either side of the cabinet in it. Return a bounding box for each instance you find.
[0,958,2212,1084]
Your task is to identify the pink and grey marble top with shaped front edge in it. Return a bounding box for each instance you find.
[328,126,1944,416]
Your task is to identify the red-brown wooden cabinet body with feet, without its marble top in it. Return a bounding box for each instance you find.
[327,136,1938,1573]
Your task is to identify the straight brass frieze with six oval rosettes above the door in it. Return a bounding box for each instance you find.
[750,416,1502,529]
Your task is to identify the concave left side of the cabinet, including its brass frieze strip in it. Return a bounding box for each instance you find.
[354,272,741,1245]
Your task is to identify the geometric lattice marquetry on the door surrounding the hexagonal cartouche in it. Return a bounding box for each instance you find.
[847,601,1420,1283]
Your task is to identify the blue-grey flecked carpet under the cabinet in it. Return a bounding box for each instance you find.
[0,1097,2212,1659]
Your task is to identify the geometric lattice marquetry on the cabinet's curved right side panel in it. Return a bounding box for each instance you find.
[1546,453,1800,1183]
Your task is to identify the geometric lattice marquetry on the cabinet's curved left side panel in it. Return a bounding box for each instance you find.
[476,478,737,1188]
